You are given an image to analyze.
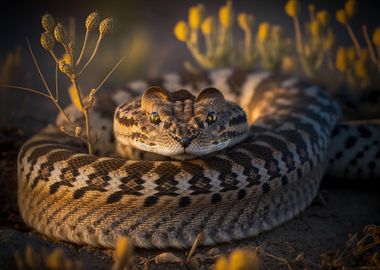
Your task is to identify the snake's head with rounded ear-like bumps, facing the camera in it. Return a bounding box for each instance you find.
[114,87,248,159]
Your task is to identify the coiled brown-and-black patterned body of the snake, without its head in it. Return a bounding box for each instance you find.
[18,70,380,248]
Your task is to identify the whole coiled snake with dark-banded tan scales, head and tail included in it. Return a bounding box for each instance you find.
[18,69,380,248]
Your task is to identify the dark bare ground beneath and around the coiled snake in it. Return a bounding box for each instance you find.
[0,126,380,269]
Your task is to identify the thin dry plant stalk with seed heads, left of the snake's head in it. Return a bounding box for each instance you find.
[3,12,125,155]
